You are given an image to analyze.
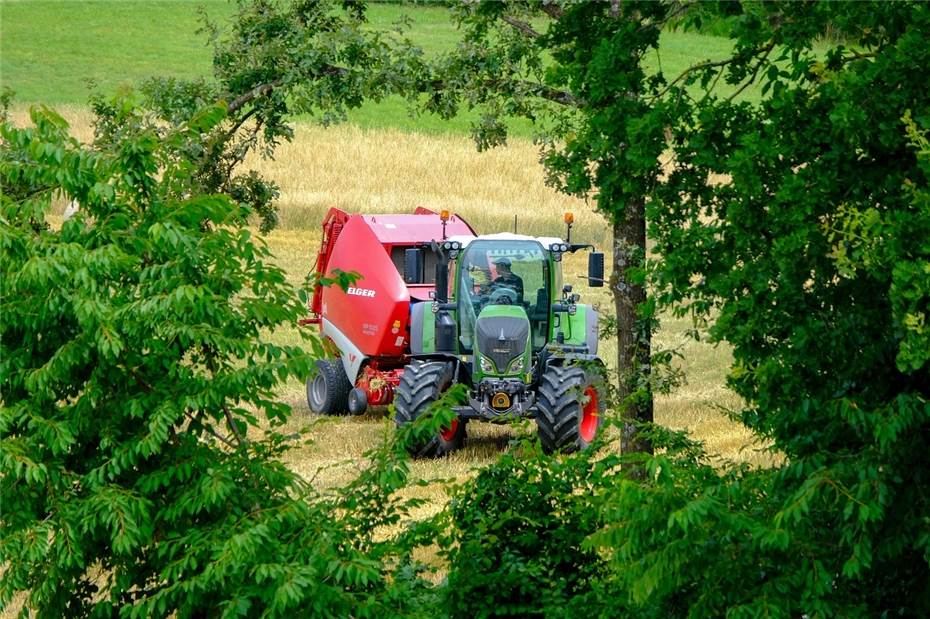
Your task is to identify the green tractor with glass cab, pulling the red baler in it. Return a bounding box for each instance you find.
[394,216,606,457]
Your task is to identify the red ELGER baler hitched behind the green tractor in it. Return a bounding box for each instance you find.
[301,208,475,414]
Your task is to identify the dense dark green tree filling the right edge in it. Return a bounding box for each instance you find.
[649,3,930,614]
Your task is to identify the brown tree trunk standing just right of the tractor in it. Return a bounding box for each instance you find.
[610,199,653,453]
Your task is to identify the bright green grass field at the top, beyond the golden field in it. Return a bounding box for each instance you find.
[0,0,753,137]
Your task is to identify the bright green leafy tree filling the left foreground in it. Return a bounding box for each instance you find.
[0,107,439,617]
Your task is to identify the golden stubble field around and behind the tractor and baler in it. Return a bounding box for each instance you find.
[14,108,770,515]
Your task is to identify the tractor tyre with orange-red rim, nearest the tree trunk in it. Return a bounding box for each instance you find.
[536,365,607,453]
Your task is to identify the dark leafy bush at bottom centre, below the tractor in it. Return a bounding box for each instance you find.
[441,447,614,617]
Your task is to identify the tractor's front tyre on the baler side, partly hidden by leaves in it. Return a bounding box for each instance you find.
[394,361,465,458]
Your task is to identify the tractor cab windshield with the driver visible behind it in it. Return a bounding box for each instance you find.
[455,240,550,352]
